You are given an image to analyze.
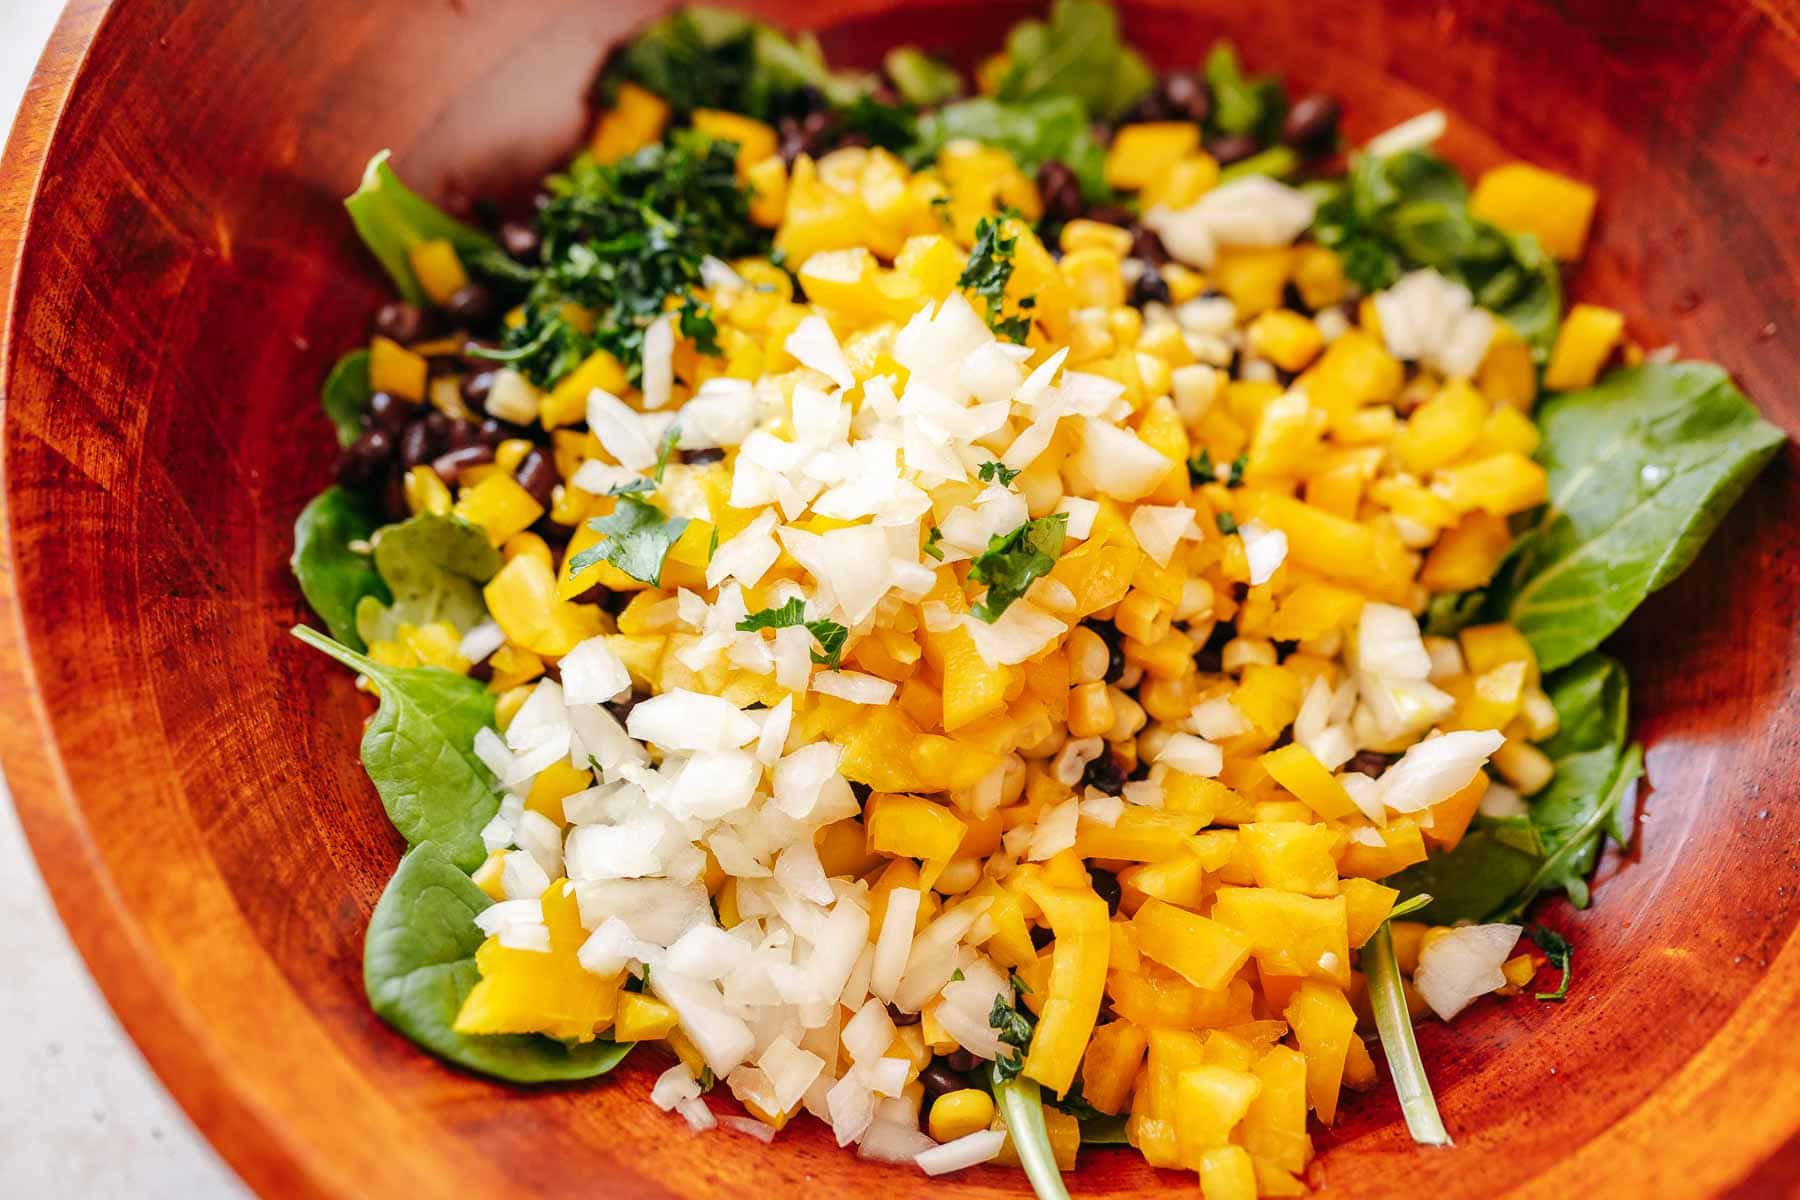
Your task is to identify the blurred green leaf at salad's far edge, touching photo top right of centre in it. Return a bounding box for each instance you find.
[995,0,1156,121]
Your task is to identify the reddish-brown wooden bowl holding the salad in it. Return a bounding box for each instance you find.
[0,0,1800,1200]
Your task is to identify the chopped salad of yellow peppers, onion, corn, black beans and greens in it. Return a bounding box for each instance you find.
[293,0,1780,1200]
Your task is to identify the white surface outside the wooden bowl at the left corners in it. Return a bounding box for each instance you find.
[0,0,248,1200]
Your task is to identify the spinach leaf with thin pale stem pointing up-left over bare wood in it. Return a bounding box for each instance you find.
[293,624,500,871]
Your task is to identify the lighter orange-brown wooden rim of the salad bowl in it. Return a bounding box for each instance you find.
[0,9,1800,1200]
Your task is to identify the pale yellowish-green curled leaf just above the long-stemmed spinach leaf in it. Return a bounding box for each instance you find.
[356,513,500,644]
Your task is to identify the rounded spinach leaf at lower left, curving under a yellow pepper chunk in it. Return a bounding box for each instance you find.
[362,842,632,1083]
